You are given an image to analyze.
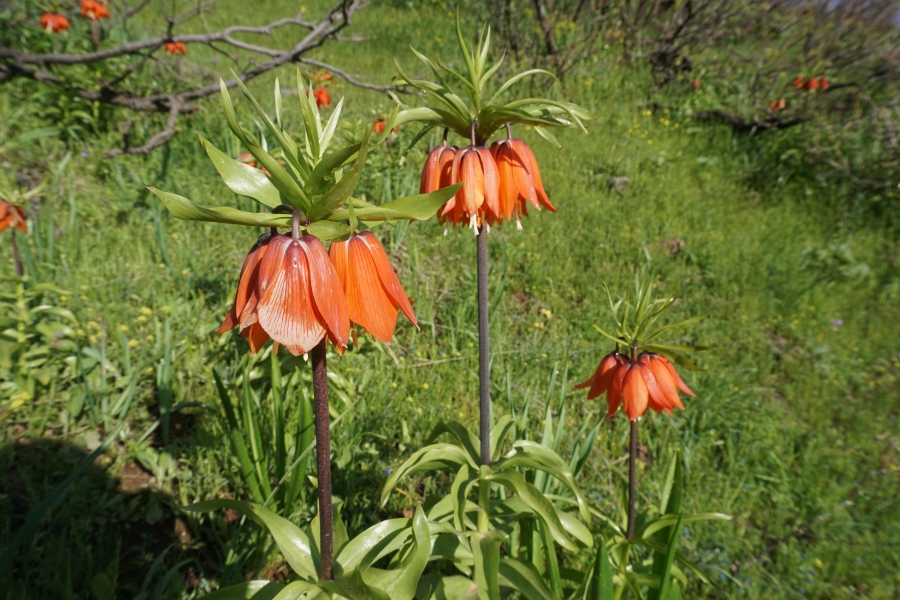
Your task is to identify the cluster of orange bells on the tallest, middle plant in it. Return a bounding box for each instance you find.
[419,138,556,228]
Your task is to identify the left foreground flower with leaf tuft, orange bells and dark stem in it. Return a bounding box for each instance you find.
[150,71,460,580]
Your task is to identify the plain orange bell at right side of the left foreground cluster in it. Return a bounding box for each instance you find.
[328,231,418,344]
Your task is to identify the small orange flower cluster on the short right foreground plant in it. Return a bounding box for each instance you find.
[575,352,695,421]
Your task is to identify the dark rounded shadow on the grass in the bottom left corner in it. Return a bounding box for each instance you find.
[0,438,198,600]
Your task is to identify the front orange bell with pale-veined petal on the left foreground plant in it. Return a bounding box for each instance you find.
[256,235,350,356]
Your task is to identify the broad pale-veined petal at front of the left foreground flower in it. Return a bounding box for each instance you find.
[257,236,325,356]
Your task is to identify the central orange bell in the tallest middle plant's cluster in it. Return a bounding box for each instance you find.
[438,146,502,227]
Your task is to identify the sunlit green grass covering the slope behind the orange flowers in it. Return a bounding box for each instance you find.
[0,2,900,598]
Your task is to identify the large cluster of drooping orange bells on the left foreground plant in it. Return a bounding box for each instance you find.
[216,232,418,356]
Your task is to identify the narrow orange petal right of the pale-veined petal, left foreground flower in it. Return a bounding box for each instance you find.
[298,235,350,353]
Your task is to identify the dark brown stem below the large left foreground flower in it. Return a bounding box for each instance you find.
[310,338,334,579]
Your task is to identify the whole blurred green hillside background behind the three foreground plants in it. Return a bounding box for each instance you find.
[0,0,900,600]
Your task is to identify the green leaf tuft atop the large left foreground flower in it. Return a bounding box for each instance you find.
[148,68,459,240]
